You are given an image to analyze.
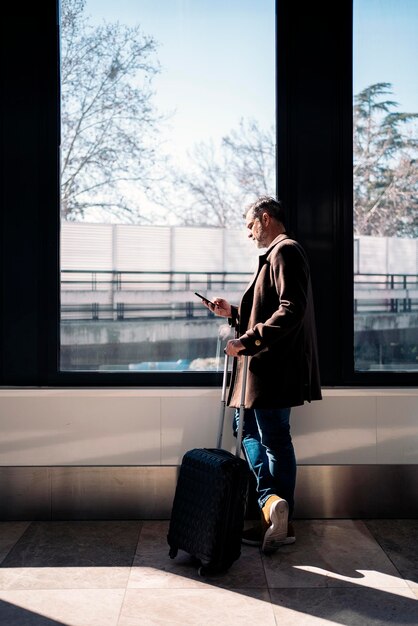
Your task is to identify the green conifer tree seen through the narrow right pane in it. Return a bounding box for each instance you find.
[353,83,418,237]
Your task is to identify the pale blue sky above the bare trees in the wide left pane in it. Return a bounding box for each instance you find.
[87,0,275,160]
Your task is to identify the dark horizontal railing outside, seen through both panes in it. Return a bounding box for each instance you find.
[61,270,418,321]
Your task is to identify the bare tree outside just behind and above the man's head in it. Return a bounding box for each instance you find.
[164,120,276,228]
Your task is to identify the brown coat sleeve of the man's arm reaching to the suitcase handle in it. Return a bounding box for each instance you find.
[240,244,309,355]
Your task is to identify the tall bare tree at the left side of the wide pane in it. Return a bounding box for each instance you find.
[61,0,162,221]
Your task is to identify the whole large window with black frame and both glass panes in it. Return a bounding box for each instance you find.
[0,0,418,386]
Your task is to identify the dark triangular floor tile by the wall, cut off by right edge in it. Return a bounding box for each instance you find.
[365,519,418,590]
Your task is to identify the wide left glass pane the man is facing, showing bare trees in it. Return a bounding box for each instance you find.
[61,0,276,371]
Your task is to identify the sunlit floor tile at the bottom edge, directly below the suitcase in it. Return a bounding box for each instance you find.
[118,588,276,626]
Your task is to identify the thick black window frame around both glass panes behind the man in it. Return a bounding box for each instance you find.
[0,0,418,387]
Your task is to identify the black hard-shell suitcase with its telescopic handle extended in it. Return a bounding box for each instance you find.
[167,356,249,576]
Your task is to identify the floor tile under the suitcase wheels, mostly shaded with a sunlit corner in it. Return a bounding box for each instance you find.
[128,522,266,589]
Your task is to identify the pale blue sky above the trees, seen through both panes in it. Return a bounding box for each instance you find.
[87,0,418,150]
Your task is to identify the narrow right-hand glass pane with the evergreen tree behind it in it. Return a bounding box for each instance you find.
[353,0,418,371]
